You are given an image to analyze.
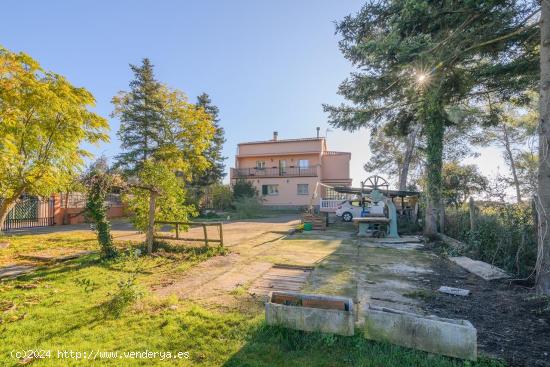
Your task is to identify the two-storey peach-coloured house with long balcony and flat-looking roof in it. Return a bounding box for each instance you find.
[230,128,351,208]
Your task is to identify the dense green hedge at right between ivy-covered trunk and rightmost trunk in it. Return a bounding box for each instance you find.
[445,203,537,278]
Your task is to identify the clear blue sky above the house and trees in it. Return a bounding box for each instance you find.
[0,0,505,186]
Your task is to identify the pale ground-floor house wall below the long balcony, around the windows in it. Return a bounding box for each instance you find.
[244,177,318,206]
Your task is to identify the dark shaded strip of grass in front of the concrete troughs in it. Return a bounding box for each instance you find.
[224,323,504,367]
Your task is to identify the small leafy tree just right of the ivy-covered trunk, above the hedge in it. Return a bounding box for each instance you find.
[442,162,489,208]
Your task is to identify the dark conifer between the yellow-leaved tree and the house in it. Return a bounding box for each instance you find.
[193,93,226,186]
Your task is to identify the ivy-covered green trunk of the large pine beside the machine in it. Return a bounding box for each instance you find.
[422,97,445,237]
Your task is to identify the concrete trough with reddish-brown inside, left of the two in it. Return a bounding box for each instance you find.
[265,292,355,336]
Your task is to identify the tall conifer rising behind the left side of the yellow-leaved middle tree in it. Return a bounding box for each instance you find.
[112,58,165,174]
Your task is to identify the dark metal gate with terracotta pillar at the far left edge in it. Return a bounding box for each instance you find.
[2,196,54,231]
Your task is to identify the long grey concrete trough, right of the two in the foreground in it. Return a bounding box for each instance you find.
[364,305,477,361]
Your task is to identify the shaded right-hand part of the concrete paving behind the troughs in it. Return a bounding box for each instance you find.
[301,228,436,312]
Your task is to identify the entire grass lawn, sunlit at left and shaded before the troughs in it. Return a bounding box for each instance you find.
[0,235,506,366]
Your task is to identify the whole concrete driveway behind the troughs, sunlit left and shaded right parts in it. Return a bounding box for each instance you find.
[154,223,435,312]
